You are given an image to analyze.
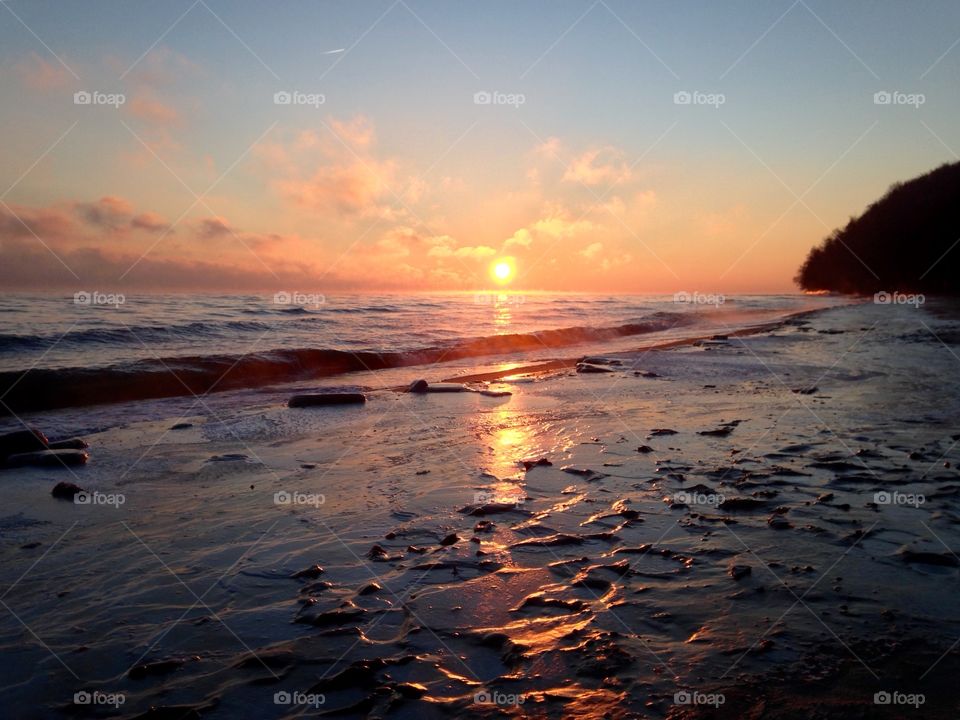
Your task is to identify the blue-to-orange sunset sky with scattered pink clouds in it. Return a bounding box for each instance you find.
[0,0,960,293]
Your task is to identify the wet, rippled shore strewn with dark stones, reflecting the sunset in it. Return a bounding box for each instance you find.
[0,305,960,719]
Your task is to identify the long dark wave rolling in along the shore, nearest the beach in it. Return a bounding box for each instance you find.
[0,312,693,413]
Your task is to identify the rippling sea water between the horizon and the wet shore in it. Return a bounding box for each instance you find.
[0,293,843,411]
